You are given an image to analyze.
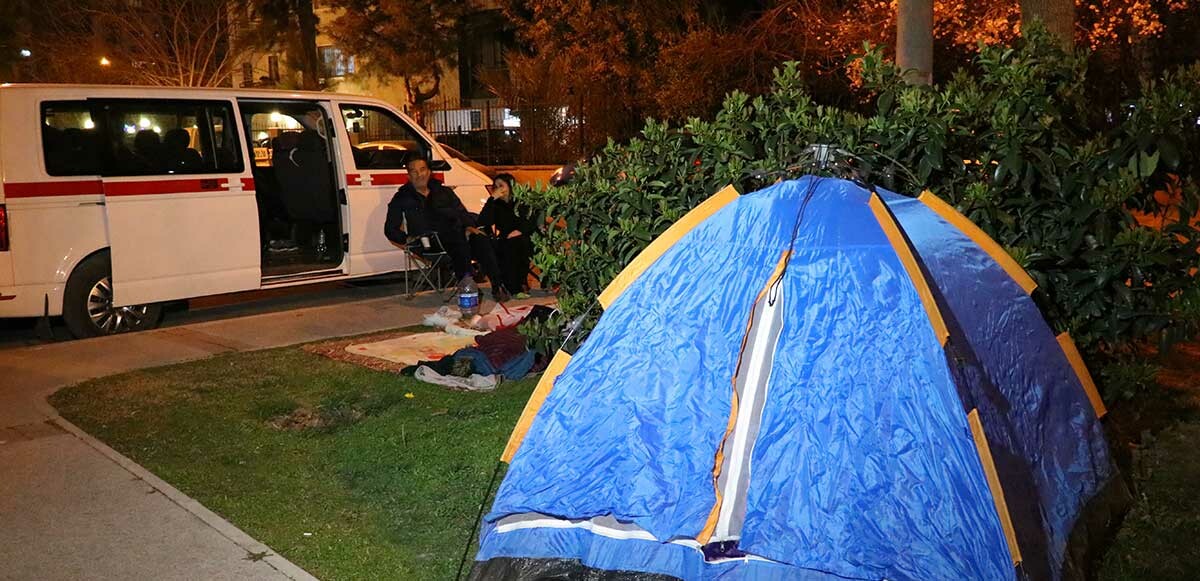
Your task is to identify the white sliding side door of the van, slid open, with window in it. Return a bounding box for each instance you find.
[89,98,260,306]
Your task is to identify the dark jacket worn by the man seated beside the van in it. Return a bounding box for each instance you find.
[383,178,474,245]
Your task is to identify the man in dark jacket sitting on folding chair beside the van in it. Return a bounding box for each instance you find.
[383,157,509,301]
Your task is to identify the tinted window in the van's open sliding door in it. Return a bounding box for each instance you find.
[104,101,244,175]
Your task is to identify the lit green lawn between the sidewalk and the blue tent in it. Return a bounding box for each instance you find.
[52,348,535,580]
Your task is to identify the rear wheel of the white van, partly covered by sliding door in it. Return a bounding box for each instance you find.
[62,252,162,339]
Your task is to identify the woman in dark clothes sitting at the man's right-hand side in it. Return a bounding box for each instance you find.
[478,174,533,298]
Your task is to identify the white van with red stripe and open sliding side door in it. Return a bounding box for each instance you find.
[0,85,491,337]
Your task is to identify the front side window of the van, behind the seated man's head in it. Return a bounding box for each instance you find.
[342,104,430,169]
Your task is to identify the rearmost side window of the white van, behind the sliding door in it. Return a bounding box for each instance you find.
[42,101,100,175]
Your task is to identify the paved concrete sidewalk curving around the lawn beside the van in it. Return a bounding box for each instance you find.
[0,293,545,580]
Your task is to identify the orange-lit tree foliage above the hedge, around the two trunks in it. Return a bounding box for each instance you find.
[497,0,1200,147]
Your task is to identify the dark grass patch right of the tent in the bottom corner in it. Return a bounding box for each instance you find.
[1100,423,1200,581]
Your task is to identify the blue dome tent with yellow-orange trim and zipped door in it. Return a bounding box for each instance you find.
[473,178,1120,580]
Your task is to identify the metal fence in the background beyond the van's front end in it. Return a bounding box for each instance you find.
[419,100,595,166]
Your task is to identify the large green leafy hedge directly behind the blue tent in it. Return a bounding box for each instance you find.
[518,30,1200,395]
